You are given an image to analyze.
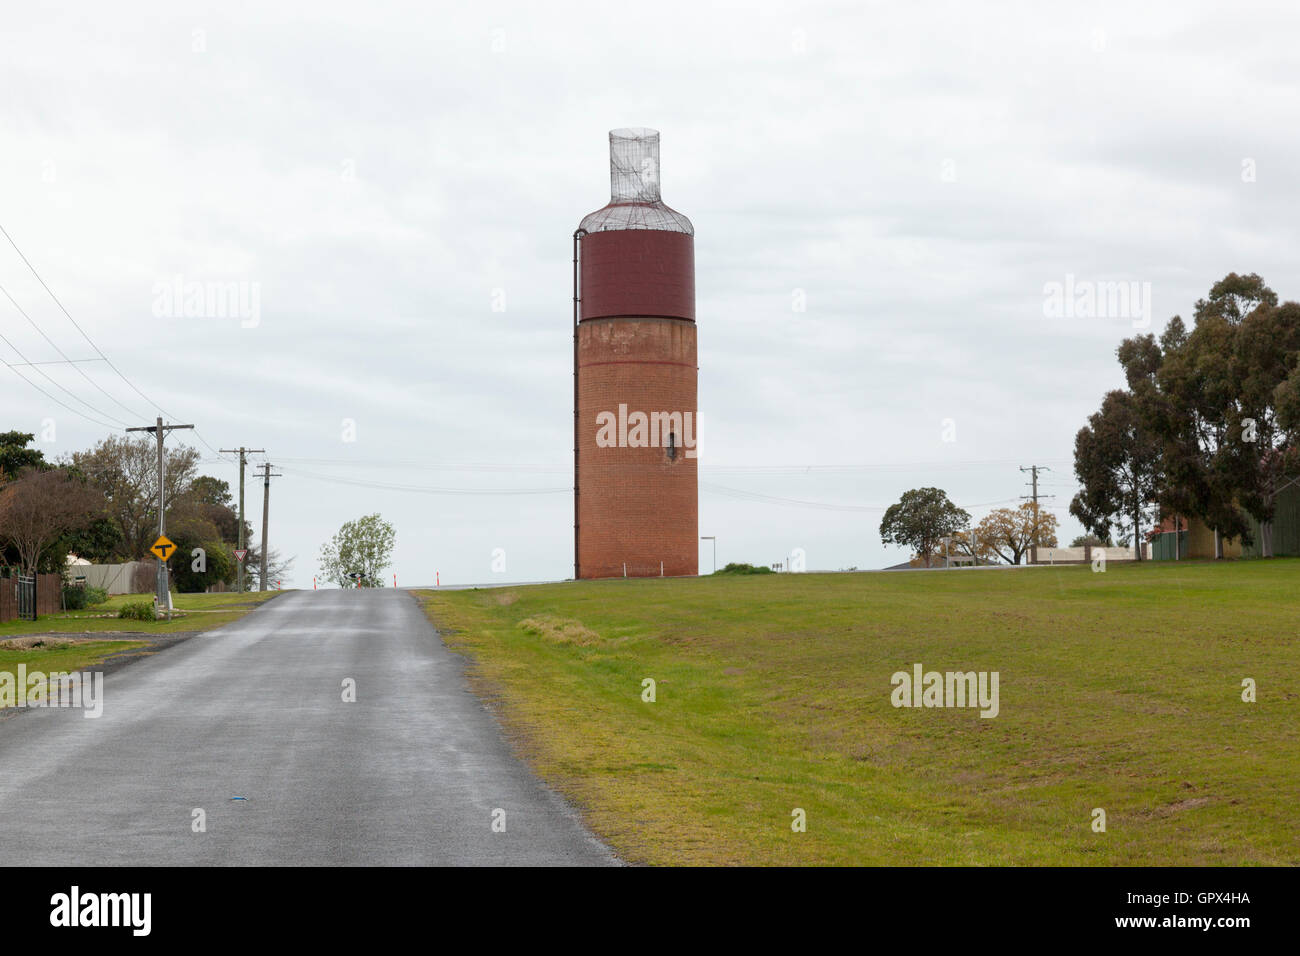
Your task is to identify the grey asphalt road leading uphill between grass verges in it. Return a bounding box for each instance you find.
[0,589,616,866]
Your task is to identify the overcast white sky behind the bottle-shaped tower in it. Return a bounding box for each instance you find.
[0,0,1300,587]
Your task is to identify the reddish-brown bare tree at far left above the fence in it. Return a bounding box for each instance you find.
[0,468,103,574]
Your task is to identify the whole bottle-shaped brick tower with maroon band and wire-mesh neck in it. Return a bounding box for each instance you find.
[573,129,699,578]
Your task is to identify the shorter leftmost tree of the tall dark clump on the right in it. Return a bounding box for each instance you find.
[1070,390,1161,561]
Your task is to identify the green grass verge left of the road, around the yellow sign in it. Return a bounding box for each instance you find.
[0,591,280,707]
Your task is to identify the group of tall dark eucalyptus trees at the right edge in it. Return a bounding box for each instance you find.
[1070,273,1300,557]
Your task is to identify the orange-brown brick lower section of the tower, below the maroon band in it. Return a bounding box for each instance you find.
[577,317,699,578]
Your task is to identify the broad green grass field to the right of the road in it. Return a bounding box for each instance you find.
[424,559,1300,865]
